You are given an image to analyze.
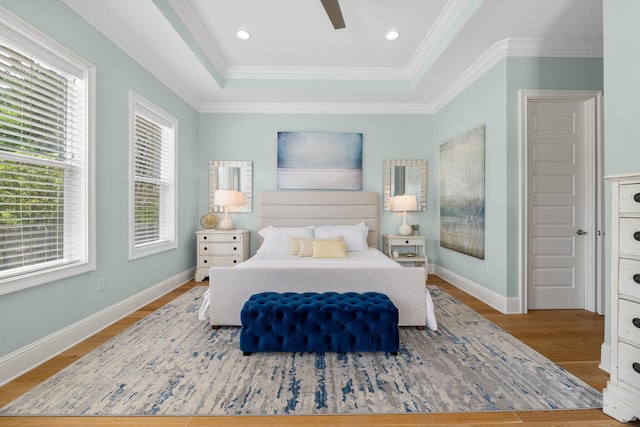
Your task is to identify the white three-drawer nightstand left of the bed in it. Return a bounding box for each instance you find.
[193,230,250,282]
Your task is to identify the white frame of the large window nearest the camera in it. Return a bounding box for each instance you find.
[0,7,96,295]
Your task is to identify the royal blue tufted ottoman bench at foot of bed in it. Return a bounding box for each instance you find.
[240,292,400,355]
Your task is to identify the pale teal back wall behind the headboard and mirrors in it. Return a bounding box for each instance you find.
[197,114,437,255]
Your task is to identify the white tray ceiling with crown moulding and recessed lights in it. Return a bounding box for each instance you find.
[65,0,602,113]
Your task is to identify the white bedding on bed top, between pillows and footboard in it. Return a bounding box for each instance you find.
[235,248,402,268]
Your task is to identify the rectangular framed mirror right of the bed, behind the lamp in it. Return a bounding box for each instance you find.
[384,160,427,211]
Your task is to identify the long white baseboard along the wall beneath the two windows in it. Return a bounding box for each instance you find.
[0,269,195,386]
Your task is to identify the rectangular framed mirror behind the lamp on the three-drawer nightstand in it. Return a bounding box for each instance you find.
[209,160,253,212]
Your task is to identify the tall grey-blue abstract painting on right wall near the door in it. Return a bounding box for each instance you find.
[440,125,485,259]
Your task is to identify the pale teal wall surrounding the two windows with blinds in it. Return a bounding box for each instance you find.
[0,0,198,357]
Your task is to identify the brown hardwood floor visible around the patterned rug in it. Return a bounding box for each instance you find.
[0,275,640,427]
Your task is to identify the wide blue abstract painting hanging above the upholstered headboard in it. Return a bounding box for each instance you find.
[277,132,362,190]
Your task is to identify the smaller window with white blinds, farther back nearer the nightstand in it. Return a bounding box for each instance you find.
[129,92,177,259]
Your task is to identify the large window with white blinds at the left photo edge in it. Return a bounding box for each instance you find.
[0,11,95,294]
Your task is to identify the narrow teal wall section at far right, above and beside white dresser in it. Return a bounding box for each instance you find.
[603,0,640,343]
